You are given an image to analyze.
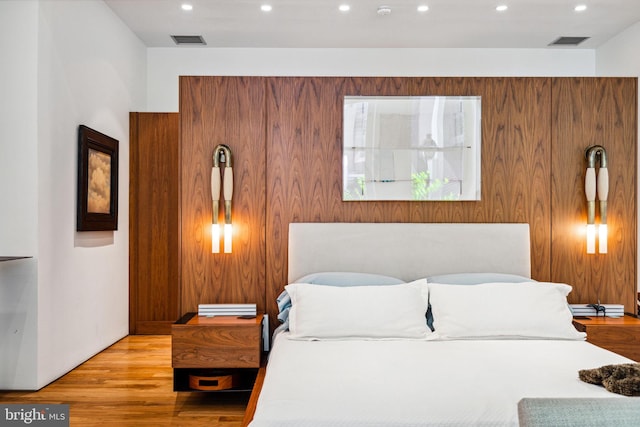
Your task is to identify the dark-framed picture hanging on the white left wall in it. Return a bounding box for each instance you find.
[76,125,118,231]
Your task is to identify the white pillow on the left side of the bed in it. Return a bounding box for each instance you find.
[285,279,431,340]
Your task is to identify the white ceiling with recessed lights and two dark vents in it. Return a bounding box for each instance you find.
[105,0,640,49]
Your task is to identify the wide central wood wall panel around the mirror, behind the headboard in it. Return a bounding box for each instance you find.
[266,77,551,324]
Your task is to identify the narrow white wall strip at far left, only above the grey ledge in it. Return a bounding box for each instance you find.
[0,0,38,258]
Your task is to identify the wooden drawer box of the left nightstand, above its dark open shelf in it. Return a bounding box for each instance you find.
[171,315,262,368]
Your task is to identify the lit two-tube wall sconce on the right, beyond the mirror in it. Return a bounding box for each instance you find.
[584,145,609,254]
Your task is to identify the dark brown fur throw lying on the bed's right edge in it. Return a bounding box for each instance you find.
[578,363,640,396]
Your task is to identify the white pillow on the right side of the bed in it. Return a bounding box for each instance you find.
[429,282,586,340]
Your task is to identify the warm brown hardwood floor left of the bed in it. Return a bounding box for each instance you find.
[0,335,249,427]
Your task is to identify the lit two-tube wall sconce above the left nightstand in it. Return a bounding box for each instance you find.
[211,144,233,254]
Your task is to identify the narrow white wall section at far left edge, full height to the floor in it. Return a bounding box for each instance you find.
[0,0,38,389]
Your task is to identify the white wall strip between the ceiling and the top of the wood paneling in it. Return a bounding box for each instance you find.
[147,47,595,111]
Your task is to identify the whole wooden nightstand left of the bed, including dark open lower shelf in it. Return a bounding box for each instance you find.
[171,313,263,391]
